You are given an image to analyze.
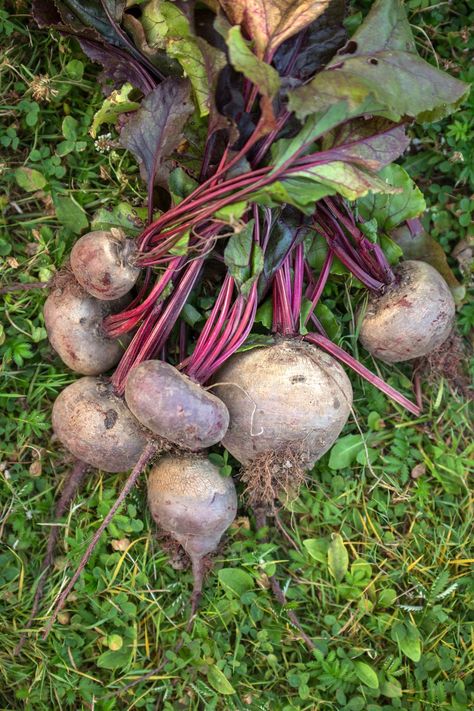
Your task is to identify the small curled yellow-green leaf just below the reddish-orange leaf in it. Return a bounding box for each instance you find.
[226,27,280,97]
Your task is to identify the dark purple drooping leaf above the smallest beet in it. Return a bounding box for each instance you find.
[120,79,193,185]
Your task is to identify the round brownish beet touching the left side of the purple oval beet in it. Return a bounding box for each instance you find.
[52,377,148,472]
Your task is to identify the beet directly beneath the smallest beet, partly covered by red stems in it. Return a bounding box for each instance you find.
[44,275,129,375]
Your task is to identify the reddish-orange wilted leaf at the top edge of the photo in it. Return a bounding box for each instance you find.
[219,0,330,59]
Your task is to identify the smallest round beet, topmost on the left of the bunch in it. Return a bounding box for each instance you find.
[71,229,140,301]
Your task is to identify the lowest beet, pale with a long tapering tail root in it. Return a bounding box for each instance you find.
[148,455,237,614]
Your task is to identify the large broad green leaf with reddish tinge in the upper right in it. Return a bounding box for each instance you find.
[289,0,469,121]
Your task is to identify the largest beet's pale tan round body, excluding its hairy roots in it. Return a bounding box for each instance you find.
[215,339,352,467]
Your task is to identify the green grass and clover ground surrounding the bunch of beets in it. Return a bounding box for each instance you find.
[0,0,474,711]
